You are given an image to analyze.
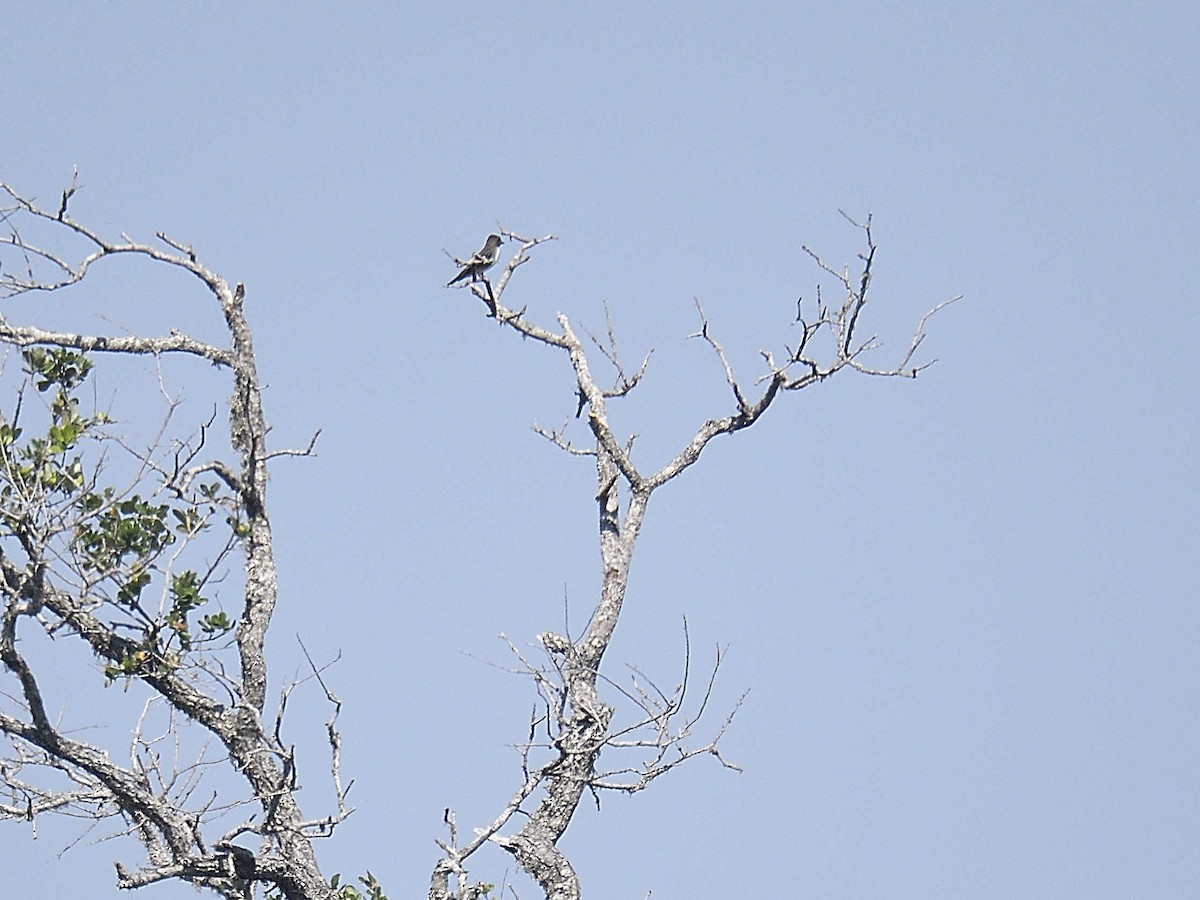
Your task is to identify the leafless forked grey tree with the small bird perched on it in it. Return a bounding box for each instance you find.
[430,225,956,900]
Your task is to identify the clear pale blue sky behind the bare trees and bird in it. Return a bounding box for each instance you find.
[0,2,1200,900]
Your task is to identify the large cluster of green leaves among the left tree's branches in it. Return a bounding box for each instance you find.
[0,347,238,686]
